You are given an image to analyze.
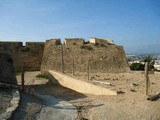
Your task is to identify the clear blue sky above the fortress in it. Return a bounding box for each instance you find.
[0,0,160,52]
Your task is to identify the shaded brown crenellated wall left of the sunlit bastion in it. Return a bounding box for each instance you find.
[0,42,45,70]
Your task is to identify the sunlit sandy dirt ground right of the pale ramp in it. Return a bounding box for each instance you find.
[74,72,160,120]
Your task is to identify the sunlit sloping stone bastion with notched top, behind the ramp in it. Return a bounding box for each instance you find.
[41,38,129,73]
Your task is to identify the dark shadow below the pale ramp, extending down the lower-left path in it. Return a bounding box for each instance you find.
[11,82,86,120]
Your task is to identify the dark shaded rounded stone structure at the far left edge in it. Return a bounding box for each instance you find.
[0,53,17,85]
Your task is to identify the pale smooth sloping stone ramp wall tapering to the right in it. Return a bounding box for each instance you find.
[49,70,117,95]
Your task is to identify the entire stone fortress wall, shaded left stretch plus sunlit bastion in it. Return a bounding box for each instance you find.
[0,38,129,73]
